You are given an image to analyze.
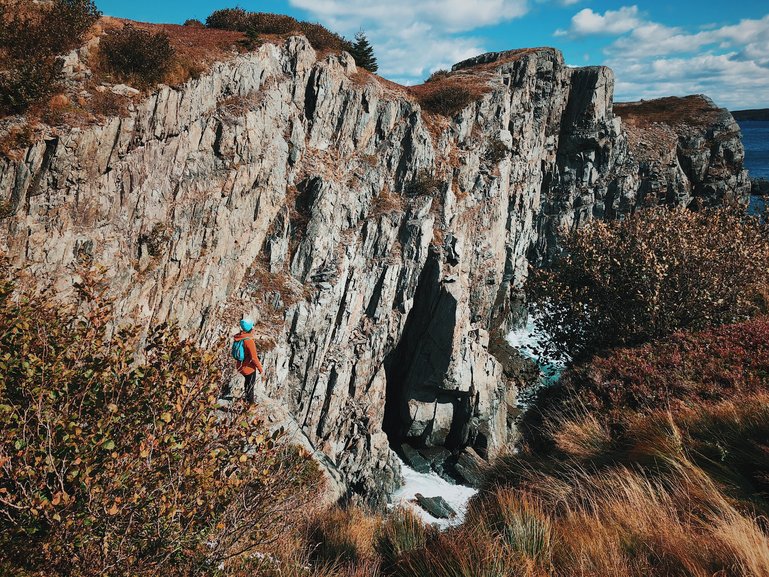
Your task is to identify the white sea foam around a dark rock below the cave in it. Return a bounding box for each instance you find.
[392,461,478,529]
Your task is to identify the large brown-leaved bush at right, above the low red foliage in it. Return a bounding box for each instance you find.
[527,207,769,361]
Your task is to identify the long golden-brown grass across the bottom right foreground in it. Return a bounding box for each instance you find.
[256,382,769,577]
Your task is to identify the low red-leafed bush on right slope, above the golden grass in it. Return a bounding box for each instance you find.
[540,317,769,428]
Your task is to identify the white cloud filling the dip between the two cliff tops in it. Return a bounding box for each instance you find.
[290,0,528,84]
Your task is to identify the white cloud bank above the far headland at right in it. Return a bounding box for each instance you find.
[556,6,769,109]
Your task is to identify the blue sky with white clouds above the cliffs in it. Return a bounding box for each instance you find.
[96,0,769,109]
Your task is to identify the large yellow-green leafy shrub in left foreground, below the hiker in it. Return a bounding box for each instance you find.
[0,275,316,577]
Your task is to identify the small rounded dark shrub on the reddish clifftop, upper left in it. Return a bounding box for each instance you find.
[100,24,174,87]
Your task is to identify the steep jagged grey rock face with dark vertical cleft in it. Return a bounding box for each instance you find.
[0,38,744,503]
